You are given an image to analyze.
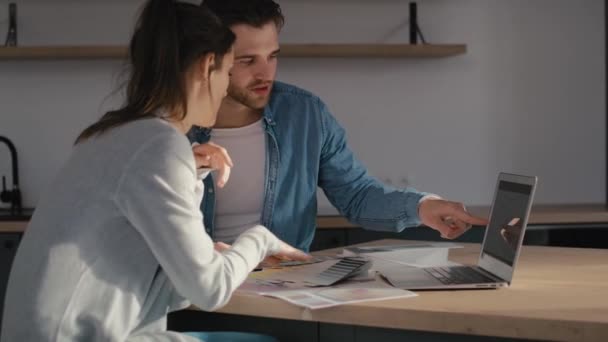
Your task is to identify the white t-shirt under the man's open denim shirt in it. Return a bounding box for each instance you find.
[211,119,266,243]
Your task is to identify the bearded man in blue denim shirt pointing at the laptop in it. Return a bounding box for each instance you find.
[190,0,486,250]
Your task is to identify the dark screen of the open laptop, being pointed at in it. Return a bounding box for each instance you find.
[483,180,532,266]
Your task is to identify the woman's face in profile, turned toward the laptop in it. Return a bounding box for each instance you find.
[201,50,234,127]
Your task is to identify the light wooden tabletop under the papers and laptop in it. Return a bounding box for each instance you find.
[210,240,608,341]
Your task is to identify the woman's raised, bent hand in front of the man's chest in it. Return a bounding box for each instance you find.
[192,142,234,188]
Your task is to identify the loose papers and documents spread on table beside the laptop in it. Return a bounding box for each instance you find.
[239,242,461,309]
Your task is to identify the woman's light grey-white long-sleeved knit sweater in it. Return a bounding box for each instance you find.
[0,119,279,342]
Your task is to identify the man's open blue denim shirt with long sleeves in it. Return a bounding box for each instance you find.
[188,81,425,250]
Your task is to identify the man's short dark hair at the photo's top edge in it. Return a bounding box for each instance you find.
[201,0,285,29]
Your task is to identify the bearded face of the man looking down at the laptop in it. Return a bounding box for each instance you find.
[228,21,279,109]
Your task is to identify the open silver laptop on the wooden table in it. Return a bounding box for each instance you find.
[390,173,537,290]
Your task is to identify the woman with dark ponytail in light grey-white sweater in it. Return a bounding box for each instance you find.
[2,0,308,342]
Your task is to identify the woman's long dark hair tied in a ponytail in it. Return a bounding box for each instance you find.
[76,0,236,143]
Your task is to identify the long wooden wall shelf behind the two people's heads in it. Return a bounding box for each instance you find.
[0,44,467,60]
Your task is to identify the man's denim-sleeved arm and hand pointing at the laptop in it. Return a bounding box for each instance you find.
[318,101,487,239]
